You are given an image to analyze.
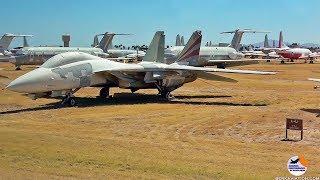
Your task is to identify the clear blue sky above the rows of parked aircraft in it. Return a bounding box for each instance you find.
[0,0,320,46]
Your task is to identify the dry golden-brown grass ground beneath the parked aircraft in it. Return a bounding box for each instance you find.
[0,62,320,179]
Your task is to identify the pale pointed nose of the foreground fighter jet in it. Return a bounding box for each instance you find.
[6,68,50,93]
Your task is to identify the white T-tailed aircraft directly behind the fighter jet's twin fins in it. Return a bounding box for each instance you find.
[165,29,265,68]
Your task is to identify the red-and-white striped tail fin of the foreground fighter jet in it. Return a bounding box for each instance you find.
[176,31,202,64]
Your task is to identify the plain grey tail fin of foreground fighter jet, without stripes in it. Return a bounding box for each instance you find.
[142,31,165,63]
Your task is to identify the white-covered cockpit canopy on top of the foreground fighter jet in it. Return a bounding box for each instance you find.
[41,52,99,68]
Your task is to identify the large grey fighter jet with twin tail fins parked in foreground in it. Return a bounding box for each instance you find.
[6,31,275,106]
